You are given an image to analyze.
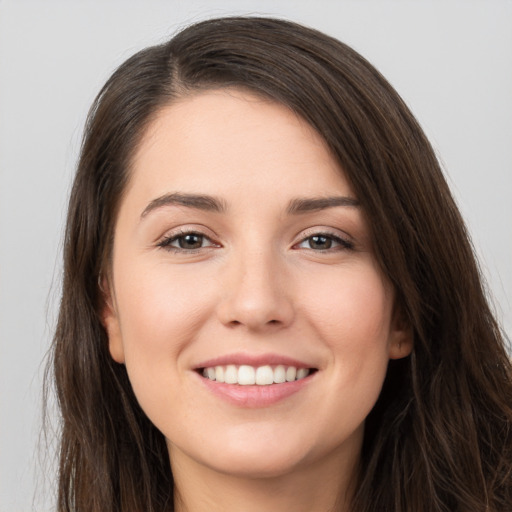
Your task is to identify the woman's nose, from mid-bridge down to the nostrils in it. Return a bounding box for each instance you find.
[217,245,294,331]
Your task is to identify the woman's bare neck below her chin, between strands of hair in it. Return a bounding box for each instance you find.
[171,444,358,512]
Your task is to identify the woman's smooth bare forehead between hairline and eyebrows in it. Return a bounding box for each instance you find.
[129,89,350,204]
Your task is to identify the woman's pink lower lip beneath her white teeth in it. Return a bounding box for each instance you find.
[197,372,317,408]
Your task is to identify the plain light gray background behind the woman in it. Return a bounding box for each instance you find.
[0,0,512,512]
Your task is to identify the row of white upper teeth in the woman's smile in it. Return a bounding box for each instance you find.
[203,364,309,386]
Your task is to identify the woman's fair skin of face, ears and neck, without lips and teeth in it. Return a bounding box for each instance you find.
[103,90,411,512]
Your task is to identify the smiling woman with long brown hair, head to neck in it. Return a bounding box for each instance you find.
[54,18,512,512]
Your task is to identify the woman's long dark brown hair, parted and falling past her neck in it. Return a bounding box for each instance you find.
[49,17,512,512]
